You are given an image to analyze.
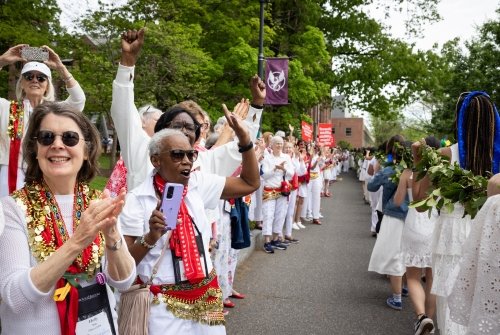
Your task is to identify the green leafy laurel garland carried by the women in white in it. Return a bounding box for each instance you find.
[410,145,488,218]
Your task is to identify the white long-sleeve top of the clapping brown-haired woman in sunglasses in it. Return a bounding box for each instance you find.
[0,196,136,335]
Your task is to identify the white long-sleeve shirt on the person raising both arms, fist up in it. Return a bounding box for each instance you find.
[111,64,262,190]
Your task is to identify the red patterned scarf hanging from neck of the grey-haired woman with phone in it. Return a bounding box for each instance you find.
[154,173,205,284]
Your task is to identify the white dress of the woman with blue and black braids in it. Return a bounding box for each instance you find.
[431,144,471,335]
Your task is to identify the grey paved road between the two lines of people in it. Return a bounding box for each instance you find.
[227,173,426,335]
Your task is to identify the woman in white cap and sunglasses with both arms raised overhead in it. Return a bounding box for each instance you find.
[0,44,85,196]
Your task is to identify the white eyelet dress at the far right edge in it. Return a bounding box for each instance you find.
[448,195,500,334]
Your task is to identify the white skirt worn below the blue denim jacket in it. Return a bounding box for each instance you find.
[368,215,406,276]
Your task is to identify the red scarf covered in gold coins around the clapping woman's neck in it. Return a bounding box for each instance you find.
[12,182,104,279]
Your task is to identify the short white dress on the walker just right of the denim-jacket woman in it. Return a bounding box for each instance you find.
[401,180,437,268]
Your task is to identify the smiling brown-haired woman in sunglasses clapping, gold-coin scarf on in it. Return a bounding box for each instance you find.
[0,102,135,335]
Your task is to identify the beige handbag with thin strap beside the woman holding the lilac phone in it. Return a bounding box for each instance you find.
[118,242,168,335]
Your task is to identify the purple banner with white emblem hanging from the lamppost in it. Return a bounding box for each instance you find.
[264,58,288,105]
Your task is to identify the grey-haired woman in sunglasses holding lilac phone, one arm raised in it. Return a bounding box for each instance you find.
[119,105,260,335]
